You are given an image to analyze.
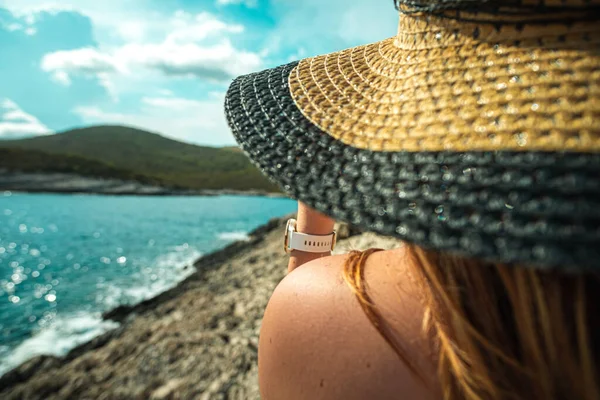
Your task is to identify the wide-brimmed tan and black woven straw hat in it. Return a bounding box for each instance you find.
[226,0,600,271]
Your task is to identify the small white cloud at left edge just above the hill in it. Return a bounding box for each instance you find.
[0,99,52,139]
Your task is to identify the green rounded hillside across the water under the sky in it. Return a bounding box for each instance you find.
[0,126,278,192]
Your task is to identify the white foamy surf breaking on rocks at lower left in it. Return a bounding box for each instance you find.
[0,312,119,376]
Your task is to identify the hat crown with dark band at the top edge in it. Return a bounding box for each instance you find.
[395,0,600,49]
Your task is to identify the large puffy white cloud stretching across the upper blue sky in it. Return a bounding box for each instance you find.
[42,11,262,86]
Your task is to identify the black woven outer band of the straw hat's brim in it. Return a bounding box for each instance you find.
[226,59,600,269]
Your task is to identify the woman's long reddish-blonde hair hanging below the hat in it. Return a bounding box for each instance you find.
[344,245,600,400]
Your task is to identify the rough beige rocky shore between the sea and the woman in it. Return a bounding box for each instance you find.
[0,218,399,400]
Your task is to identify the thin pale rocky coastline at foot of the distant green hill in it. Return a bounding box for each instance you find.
[0,169,287,197]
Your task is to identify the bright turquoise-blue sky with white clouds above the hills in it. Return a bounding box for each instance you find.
[0,0,397,146]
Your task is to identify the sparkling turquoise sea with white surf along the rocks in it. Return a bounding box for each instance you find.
[0,192,296,375]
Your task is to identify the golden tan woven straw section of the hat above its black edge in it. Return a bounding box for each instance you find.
[290,12,600,152]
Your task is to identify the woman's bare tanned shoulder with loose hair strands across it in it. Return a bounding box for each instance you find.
[259,250,438,400]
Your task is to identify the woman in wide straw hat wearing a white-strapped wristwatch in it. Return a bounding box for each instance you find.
[226,0,600,399]
